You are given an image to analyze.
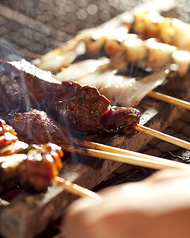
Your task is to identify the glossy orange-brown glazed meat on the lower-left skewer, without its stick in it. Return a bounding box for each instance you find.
[0,143,63,191]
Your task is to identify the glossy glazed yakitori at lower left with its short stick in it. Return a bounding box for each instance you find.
[0,119,101,200]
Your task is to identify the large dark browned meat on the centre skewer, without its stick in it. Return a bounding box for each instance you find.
[0,60,140,133]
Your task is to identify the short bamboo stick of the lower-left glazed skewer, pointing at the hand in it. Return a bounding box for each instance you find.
[53,176,102,201]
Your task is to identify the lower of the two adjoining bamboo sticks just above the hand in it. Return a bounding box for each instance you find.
[62,146,190,170]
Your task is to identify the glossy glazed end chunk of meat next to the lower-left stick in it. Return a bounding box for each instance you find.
[17,143,63,191]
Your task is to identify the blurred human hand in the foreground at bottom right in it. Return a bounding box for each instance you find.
[64,170,190,238]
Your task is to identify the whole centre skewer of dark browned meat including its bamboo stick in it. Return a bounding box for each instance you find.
[0,61,190,152]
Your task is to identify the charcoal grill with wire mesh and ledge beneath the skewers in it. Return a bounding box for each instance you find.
[0,0,190,238]
